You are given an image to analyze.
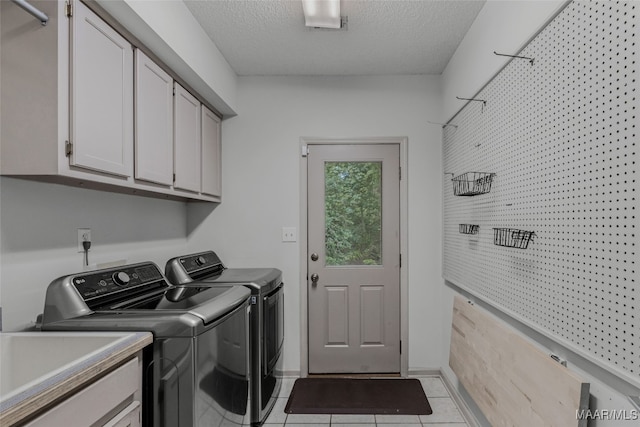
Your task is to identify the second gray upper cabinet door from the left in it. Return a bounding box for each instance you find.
[135,49,173,185]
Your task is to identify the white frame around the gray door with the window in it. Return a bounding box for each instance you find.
[298,137,409,378]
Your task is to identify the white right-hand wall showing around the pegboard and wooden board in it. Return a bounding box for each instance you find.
[440,0,637,427]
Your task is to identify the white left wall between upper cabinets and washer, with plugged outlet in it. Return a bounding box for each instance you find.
[0,177,187,331]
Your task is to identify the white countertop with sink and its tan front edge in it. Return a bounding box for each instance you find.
[0,332,153,426]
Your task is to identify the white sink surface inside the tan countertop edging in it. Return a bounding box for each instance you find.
[0,332,133,410]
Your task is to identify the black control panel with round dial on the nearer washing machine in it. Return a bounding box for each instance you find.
[72,263,169,301]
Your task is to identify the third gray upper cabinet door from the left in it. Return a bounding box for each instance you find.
[173,83,201,192]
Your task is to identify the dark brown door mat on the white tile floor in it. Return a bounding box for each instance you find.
[284,378,432,415]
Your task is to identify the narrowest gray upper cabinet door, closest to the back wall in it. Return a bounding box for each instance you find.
[201,105,222,196]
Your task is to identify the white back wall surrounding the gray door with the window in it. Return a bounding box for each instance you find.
[188,76,443,371]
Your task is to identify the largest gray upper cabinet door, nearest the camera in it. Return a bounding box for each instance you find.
[70,2,133,177]
